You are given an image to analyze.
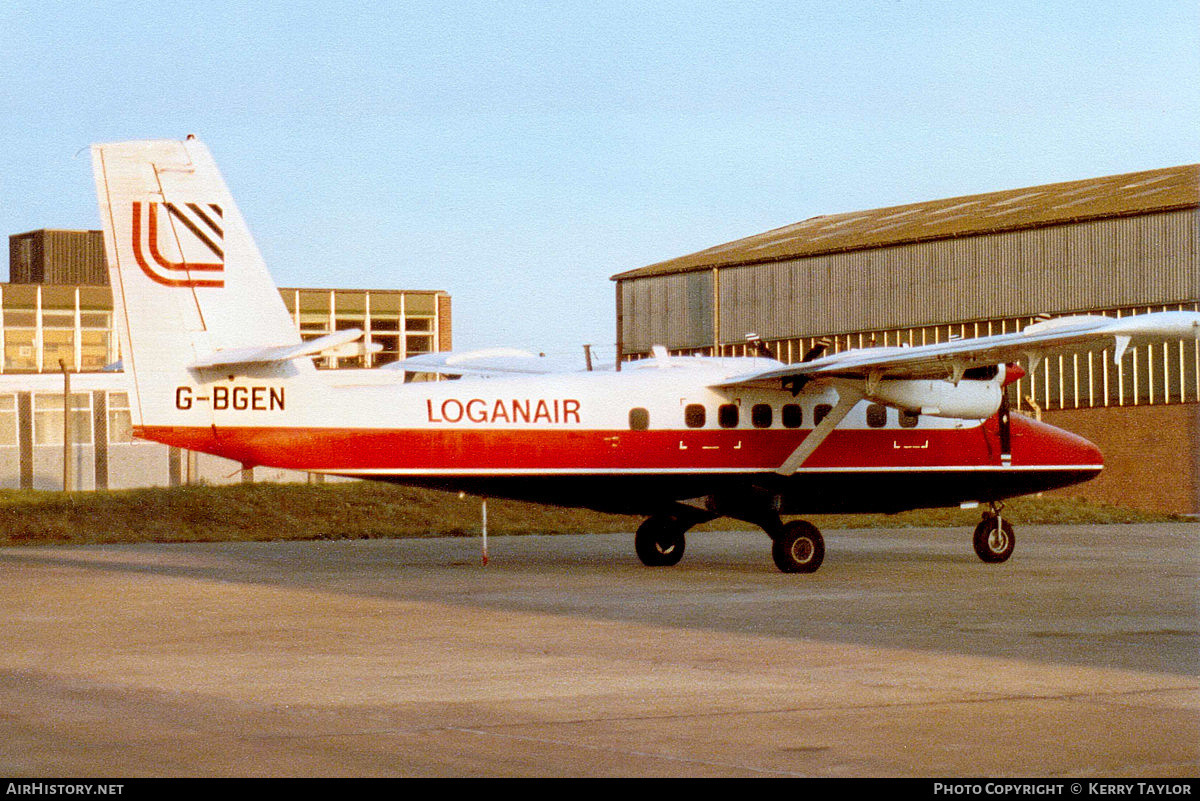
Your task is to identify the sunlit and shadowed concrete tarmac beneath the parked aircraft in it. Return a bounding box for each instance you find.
[0,524,1200,778]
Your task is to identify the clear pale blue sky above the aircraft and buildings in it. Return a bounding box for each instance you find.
[0,0,1200,355]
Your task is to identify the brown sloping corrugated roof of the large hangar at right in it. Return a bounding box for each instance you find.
[612,164,1200,281]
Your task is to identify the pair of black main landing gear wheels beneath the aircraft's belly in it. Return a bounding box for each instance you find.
[634,514,824,573]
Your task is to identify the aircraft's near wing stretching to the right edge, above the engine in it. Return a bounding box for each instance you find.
[715,312,1200,389]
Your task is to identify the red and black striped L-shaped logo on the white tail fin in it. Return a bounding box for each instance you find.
[132,201,224,288]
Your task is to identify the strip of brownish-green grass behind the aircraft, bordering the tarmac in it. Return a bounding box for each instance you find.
[0,482,1189,546]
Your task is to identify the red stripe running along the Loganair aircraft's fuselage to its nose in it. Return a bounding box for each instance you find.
[136,416,1102,475]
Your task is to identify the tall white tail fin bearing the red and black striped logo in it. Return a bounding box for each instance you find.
[92,137,313,426]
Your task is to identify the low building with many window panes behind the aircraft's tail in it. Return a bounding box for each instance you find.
[0,229,451,489]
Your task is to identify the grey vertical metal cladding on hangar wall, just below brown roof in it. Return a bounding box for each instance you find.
[620,209,1200,353]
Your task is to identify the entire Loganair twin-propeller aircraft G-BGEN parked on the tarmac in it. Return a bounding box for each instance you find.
[92,137,1200,573]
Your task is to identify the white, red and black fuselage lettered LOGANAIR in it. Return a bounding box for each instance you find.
[136,359,1102,514]
